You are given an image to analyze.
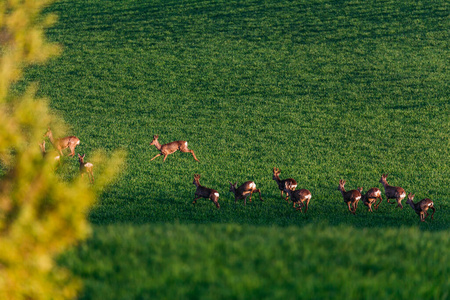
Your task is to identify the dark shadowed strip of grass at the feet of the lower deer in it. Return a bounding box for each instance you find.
[89,197,450,231]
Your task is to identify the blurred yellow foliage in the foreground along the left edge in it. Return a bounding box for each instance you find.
[0,0,123,299]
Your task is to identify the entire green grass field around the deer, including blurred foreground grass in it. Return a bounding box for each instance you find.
[22,0,450,299]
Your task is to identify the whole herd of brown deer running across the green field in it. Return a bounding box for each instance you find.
[39,129,436,222]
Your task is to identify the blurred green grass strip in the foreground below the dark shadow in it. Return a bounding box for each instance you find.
[61,224,450,299]
